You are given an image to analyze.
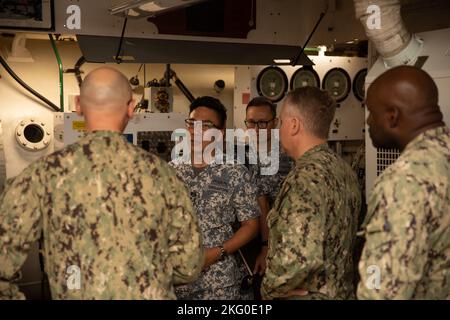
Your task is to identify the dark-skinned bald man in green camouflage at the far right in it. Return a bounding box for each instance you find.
[358,66,450,299]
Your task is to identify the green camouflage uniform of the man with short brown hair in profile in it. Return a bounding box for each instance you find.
[261,144,361,299]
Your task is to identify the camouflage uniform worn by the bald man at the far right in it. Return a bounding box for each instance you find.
[358,127,450,299]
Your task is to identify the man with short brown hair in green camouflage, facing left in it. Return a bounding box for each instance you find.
[261,87,360,299]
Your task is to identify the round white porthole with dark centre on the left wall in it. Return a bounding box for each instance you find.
[16,119,52,151]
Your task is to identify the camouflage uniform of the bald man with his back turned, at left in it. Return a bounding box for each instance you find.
[0,131,203,299]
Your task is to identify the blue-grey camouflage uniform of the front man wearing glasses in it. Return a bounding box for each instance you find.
[170,160,259,300]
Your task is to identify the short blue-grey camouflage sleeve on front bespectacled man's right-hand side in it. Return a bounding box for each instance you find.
[232,167,260,222]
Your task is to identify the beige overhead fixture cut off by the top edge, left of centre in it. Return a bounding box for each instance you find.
[110,0,208,18]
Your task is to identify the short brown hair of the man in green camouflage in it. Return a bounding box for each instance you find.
[287,86,336,139]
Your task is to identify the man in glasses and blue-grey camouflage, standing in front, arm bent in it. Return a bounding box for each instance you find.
[171,97,259,300]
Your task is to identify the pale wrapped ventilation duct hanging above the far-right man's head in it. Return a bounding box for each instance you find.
[354,0,423,68]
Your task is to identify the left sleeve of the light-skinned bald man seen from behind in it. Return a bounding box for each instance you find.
[0,170,42,299]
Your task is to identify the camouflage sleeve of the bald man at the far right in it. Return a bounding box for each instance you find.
[357,175,431,299]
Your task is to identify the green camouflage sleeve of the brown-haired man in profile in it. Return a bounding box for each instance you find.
[261,178,324,299]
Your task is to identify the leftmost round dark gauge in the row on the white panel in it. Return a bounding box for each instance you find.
[256,67,288,102]
